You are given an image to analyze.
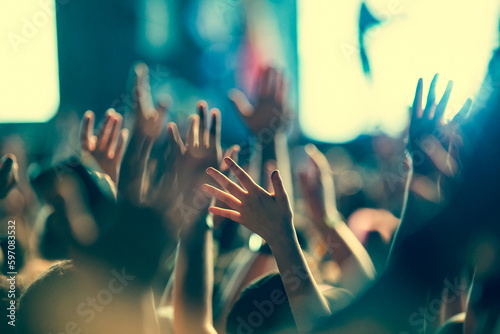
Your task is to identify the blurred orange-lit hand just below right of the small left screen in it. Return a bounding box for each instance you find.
[80,109,128,184]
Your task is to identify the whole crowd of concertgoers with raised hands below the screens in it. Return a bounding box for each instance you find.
[0,27,500,334]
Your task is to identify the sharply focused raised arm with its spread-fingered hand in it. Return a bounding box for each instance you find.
[203,158,330,331]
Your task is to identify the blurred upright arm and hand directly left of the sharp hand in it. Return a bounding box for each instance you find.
[169,101,221,334]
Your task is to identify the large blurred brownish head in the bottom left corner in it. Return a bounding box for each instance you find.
[17,261,141,334]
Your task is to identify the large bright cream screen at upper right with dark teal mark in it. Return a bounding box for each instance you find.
[297,0,499,142]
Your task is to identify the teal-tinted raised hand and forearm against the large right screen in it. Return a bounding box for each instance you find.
[391,74,472,253]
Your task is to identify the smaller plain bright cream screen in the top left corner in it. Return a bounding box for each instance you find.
[0,0,59,123]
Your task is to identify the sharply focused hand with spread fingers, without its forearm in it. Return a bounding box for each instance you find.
[203,158,295,245]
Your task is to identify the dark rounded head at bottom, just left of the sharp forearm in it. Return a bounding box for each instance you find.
[226,274,298,334]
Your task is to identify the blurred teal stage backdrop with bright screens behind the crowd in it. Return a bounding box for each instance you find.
[0,0,500,217]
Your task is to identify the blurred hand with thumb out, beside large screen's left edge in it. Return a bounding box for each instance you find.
[229,67,290,138]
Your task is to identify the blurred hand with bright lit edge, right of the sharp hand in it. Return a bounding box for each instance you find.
[299,144,338,227]
